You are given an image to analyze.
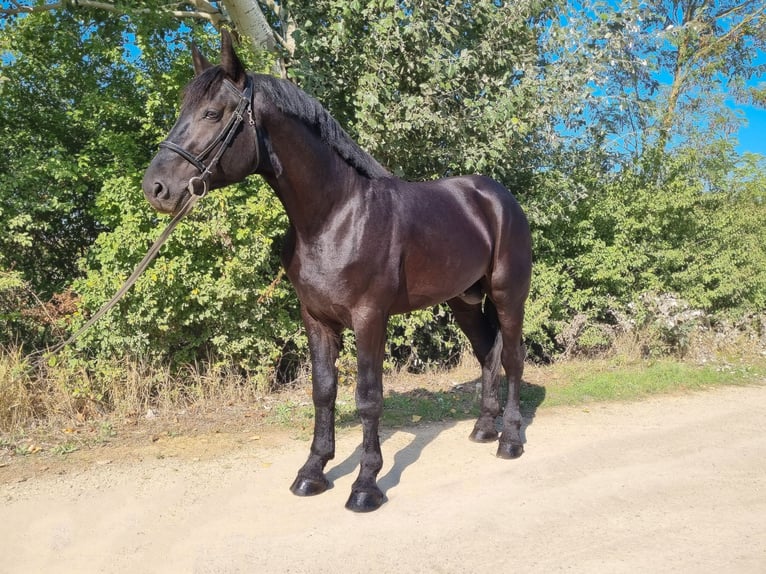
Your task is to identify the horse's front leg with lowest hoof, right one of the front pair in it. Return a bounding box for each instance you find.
[346,312,388,512]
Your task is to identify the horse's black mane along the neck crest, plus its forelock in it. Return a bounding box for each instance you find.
[184,70,391,179]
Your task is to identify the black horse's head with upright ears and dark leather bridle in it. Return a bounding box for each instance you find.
[143,31,258,213]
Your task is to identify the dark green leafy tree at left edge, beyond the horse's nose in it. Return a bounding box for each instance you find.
[0,9,155,297]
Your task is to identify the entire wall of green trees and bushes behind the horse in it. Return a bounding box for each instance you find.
[0,0,766,382]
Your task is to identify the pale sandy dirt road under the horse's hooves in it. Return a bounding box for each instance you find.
[0,387,766,573]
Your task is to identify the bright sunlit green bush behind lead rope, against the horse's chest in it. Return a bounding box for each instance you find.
[75,182,305,388]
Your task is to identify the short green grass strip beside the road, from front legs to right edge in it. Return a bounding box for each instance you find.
[266,357,766,436]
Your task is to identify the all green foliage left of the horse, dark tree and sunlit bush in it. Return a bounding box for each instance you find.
[0,7,303,382]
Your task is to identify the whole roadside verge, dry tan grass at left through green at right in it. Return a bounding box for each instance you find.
[0,342,766,458]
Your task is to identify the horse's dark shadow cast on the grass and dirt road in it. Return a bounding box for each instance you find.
[326,379,545,494]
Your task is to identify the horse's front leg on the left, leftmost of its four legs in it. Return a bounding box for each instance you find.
[290,307,340,496]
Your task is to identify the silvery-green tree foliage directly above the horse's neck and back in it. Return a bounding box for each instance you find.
[292,0,547,187]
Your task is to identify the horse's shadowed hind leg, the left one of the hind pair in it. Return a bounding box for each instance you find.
[447,296,503,442]
